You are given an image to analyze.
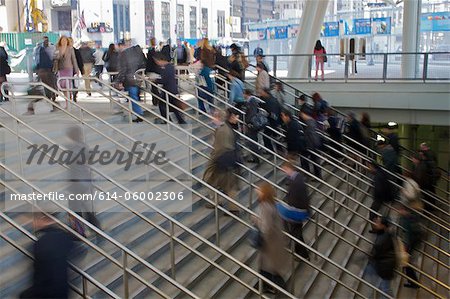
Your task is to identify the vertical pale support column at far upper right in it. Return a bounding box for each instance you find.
[401,0,422,78]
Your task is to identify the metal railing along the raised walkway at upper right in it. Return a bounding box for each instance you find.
[249,52,450,82]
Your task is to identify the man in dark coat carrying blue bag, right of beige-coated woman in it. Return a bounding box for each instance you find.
[281,162,310,260]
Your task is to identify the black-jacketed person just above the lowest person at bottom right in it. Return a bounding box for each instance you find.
[368,161,394,233]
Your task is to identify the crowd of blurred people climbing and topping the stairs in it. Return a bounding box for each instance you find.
[0,36,439,294]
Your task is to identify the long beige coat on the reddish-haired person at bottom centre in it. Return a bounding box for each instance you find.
[256,202,289,276]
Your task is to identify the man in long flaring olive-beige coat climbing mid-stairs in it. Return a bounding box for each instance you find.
[203,108,242,214]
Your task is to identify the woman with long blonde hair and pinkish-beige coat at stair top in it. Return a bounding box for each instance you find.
[52,35,80,111]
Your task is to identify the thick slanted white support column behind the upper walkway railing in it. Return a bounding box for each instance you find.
[288,0,330,78]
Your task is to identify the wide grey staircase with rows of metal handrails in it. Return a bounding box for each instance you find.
[0,72,448,298]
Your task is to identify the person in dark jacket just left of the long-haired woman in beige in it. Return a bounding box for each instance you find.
[34,36,56,101]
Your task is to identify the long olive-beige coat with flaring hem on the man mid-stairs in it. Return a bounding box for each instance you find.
[203,123,238,194]
